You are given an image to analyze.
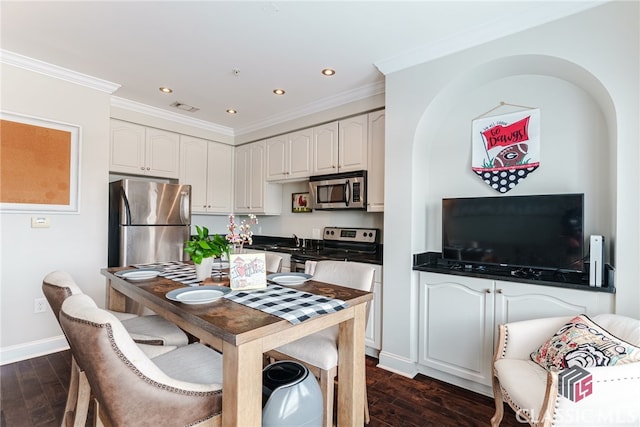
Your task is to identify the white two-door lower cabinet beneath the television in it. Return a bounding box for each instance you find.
[418,272,613,393]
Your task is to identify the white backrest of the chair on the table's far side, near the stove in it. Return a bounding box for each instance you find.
[313,261,376,292]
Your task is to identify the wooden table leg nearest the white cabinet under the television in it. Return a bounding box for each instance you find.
[337,304,366,427]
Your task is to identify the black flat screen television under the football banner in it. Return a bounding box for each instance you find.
[442,194,584,272]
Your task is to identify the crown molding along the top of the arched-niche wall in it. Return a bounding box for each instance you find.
[374,0,611,75]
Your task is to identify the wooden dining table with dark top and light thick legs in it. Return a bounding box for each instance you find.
[101,267,373,427]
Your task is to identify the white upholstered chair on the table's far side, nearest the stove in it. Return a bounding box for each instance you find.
[267,261,375,426]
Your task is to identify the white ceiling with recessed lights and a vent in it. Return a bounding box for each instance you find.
[0,0,602,135]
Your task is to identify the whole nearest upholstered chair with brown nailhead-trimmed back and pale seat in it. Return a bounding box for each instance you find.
[60,294,222,427]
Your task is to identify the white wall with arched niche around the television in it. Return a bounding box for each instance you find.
[380,2,640,376]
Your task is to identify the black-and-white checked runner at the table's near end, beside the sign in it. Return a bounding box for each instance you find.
[224,285,348,325]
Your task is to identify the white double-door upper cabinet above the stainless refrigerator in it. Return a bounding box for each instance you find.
[109,119,180,179]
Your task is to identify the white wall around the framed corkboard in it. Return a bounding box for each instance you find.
[0,65,110,363]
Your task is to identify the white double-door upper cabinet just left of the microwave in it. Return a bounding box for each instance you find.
[266,128,313,182]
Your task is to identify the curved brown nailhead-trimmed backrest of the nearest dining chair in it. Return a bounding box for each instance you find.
[60,294,222,426]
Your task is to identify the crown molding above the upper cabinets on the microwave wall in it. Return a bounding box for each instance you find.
[236,80,385,136]
